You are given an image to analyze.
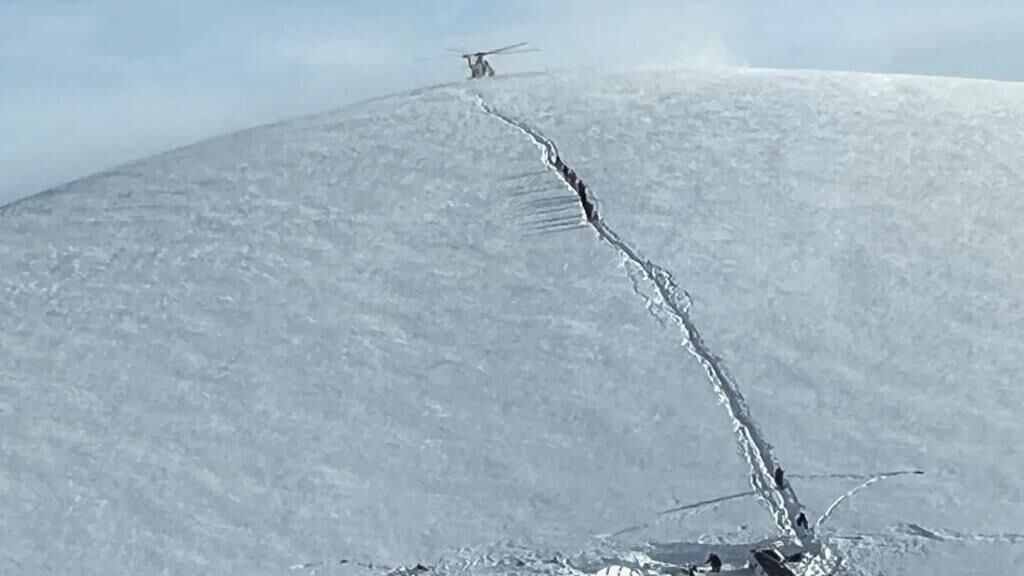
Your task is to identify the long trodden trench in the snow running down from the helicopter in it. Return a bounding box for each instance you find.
[476,94,814,539]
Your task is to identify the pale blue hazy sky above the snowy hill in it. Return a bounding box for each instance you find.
[0,0,1024,202]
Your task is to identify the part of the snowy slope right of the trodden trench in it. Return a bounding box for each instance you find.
[477,72,1024,573]
